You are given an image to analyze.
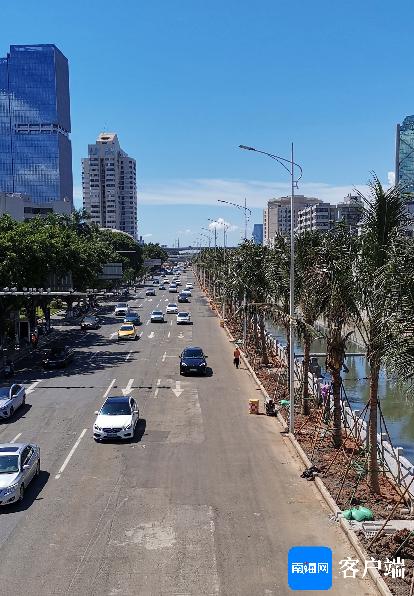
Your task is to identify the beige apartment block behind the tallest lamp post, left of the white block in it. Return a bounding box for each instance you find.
[263,195,322,246]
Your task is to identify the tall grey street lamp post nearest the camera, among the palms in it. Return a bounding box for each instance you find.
[239,143,302,435]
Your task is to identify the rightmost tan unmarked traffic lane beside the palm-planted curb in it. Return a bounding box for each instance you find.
[187,288,376,594]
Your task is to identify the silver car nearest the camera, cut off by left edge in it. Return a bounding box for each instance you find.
[0,443,40,506]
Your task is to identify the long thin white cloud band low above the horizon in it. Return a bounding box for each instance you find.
[138,178,367,210]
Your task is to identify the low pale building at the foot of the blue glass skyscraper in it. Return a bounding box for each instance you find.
[0,192,72,221]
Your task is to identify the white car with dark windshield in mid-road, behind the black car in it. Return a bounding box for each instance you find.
[93,395,139,441]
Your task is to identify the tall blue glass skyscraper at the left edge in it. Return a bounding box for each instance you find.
[0,45,73,204]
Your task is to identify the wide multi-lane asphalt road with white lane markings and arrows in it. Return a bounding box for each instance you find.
[0,273,377,596]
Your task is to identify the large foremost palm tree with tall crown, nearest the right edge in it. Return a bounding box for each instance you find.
[355,175,409,493]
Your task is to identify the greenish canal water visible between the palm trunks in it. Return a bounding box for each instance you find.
[266,321,414,463]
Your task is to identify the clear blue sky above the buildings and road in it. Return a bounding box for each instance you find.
[0,0,414,244]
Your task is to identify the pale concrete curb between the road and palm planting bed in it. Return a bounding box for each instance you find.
[215,310,393,596]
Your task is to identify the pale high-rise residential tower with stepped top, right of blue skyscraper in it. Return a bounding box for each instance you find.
[82,132,137,239]
